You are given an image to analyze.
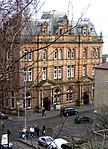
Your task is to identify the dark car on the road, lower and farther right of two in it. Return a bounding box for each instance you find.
[74,116,93,124]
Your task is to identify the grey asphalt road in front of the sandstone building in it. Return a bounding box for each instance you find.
[0,106,93,148]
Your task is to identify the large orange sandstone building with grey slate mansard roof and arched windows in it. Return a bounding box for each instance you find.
[0,12,103,111]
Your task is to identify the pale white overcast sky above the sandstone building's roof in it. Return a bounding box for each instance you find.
[38,0,108,54]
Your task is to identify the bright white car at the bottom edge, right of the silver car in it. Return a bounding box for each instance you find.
[48,138,68,149]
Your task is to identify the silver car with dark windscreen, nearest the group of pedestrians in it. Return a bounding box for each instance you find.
[38,136,54,147]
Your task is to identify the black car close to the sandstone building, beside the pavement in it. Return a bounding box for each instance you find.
[60,108,78,116]
